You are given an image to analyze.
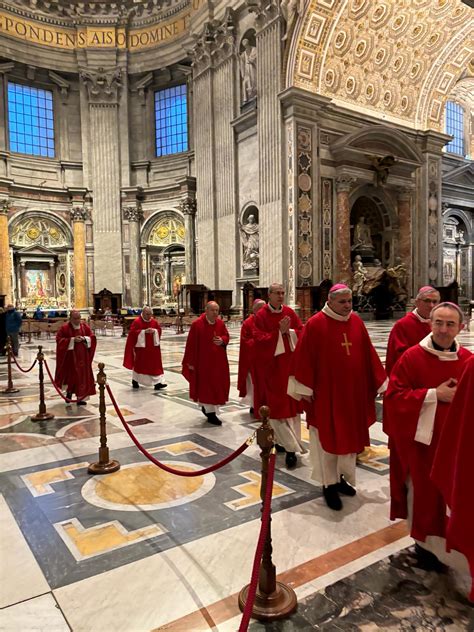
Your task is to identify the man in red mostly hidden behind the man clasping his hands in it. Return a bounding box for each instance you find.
[237,298,265,414]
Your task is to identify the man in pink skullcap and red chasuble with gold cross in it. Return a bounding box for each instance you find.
[288,283,386,511]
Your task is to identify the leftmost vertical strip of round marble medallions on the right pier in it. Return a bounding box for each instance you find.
[296,125,313,286]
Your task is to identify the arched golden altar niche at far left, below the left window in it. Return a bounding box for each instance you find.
[9,214,73,307]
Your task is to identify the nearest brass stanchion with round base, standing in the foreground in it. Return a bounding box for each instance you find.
[239,406,297,621]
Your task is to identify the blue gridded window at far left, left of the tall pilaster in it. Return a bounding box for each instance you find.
[8,82,54,158]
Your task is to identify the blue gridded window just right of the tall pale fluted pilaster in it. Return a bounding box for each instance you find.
[155,84,188,156]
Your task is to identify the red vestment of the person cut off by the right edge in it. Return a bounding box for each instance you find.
[431,355,474,601]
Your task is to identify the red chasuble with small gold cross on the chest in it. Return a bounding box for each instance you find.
[293,312,386,454]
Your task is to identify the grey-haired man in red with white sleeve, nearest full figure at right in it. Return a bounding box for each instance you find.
[384,303,471,569]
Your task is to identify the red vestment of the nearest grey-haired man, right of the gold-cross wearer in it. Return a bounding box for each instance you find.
[384,344,471,542]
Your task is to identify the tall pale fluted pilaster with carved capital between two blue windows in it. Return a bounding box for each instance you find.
[80,68,124,294]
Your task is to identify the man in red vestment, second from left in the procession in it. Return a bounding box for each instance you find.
[123,307,167,391]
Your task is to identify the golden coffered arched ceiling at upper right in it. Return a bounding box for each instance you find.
[288,0,474,130]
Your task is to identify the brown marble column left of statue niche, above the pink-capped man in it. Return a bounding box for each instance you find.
[333,175,355,283]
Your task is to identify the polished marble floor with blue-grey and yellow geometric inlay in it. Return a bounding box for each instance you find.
[0,322,474,632]
